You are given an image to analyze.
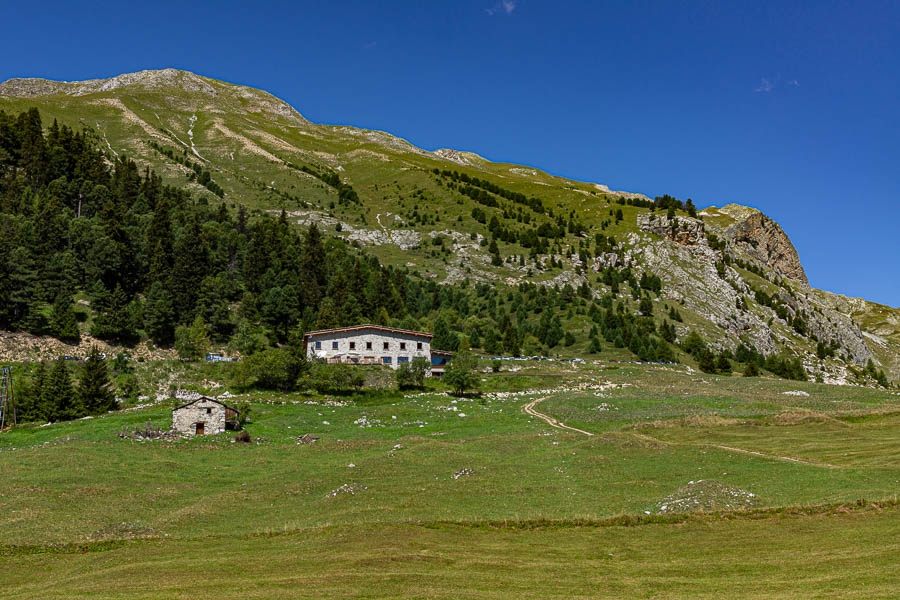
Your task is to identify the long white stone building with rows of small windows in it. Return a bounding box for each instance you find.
[303,325,432,369]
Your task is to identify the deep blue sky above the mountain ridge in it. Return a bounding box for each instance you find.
[0,0,900,306]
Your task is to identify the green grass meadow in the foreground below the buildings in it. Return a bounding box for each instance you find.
[0,362,900,598]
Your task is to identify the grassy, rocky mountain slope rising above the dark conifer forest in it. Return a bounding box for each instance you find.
[0,69,900,382]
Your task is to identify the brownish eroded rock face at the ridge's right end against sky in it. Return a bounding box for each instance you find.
[725,212,809,286]
